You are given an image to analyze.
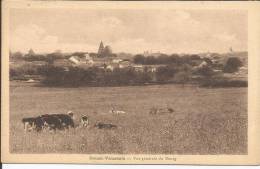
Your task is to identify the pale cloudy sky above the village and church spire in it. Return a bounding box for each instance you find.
[9,8,247,54]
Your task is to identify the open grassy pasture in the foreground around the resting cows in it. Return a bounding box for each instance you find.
[9,82,247,154]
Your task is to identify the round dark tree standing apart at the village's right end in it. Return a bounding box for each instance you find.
[223,57,242,73]
